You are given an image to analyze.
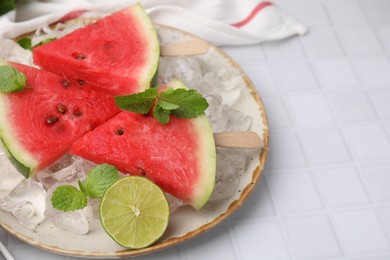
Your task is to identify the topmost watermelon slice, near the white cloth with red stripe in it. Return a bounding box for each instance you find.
[33,4,160,95]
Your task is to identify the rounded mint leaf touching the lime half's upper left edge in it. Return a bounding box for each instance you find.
[79,163,119,199]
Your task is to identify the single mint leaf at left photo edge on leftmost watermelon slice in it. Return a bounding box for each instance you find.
[0,65,27,93]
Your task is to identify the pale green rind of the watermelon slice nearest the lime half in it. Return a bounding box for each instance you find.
[169,80,217,210]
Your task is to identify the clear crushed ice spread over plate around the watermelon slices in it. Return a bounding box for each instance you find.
[0,24,252,234]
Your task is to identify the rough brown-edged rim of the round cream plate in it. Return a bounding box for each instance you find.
[0,18,269,259]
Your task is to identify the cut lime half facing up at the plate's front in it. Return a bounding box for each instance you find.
[100,176,169,249]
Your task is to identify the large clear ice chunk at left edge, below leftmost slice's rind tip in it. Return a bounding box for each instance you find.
[0,179,46,229]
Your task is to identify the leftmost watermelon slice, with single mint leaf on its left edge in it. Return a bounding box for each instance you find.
[0,63,119,177]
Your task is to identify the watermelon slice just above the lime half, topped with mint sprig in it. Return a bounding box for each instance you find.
[71,81,216,209]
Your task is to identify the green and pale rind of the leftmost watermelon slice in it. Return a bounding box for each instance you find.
[0,94,38,178]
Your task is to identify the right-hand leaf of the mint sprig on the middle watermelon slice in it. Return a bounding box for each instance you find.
[158,88,209,118]
